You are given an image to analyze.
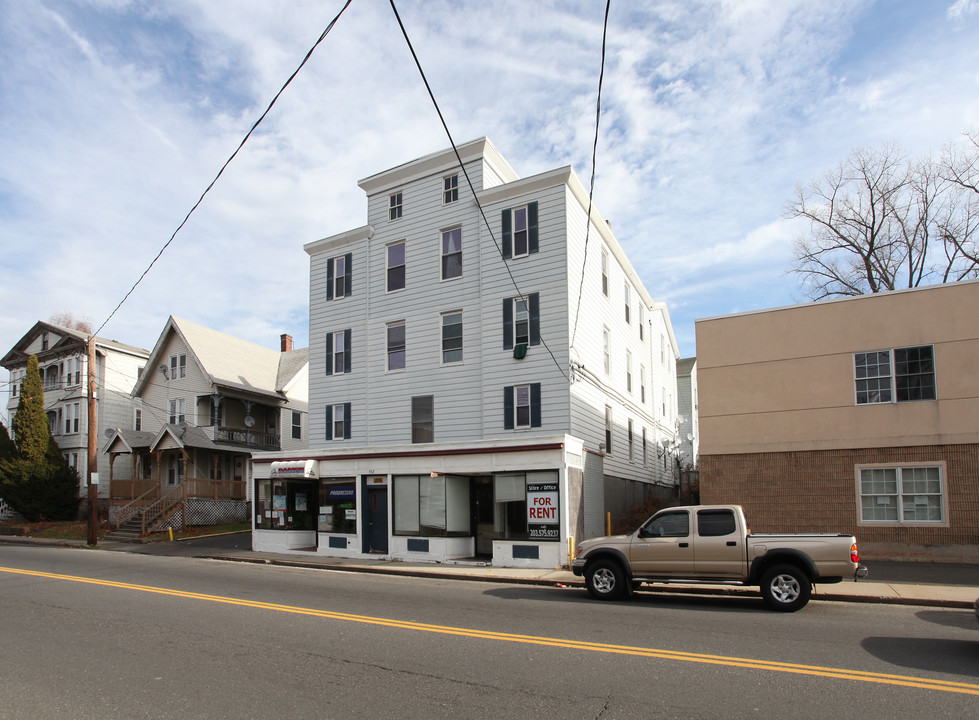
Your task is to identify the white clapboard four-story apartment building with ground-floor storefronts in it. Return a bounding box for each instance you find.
[253,138,678,567]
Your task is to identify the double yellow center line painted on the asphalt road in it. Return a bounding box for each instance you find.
[7,567,979,695]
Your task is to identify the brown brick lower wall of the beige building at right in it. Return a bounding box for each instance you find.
[700,444,979,548]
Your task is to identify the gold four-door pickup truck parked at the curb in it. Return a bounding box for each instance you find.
[571,505,867,612]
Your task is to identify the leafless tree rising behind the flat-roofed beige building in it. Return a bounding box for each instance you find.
[786,139,979,300]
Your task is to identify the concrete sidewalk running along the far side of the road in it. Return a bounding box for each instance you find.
[7,536,979,610]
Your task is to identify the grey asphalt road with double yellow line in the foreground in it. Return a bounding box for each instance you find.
[0,545,979,720]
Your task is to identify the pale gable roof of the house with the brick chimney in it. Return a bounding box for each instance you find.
[133,315,309,399]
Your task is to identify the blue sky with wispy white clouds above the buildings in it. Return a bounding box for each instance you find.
[0,0,979,414]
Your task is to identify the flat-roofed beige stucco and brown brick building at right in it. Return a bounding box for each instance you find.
[697,281,979,562]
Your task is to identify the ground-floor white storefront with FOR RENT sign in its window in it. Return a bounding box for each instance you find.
[252,435,584,568]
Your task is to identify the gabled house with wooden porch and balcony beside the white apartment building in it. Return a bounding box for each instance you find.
[103,317,309,532]
